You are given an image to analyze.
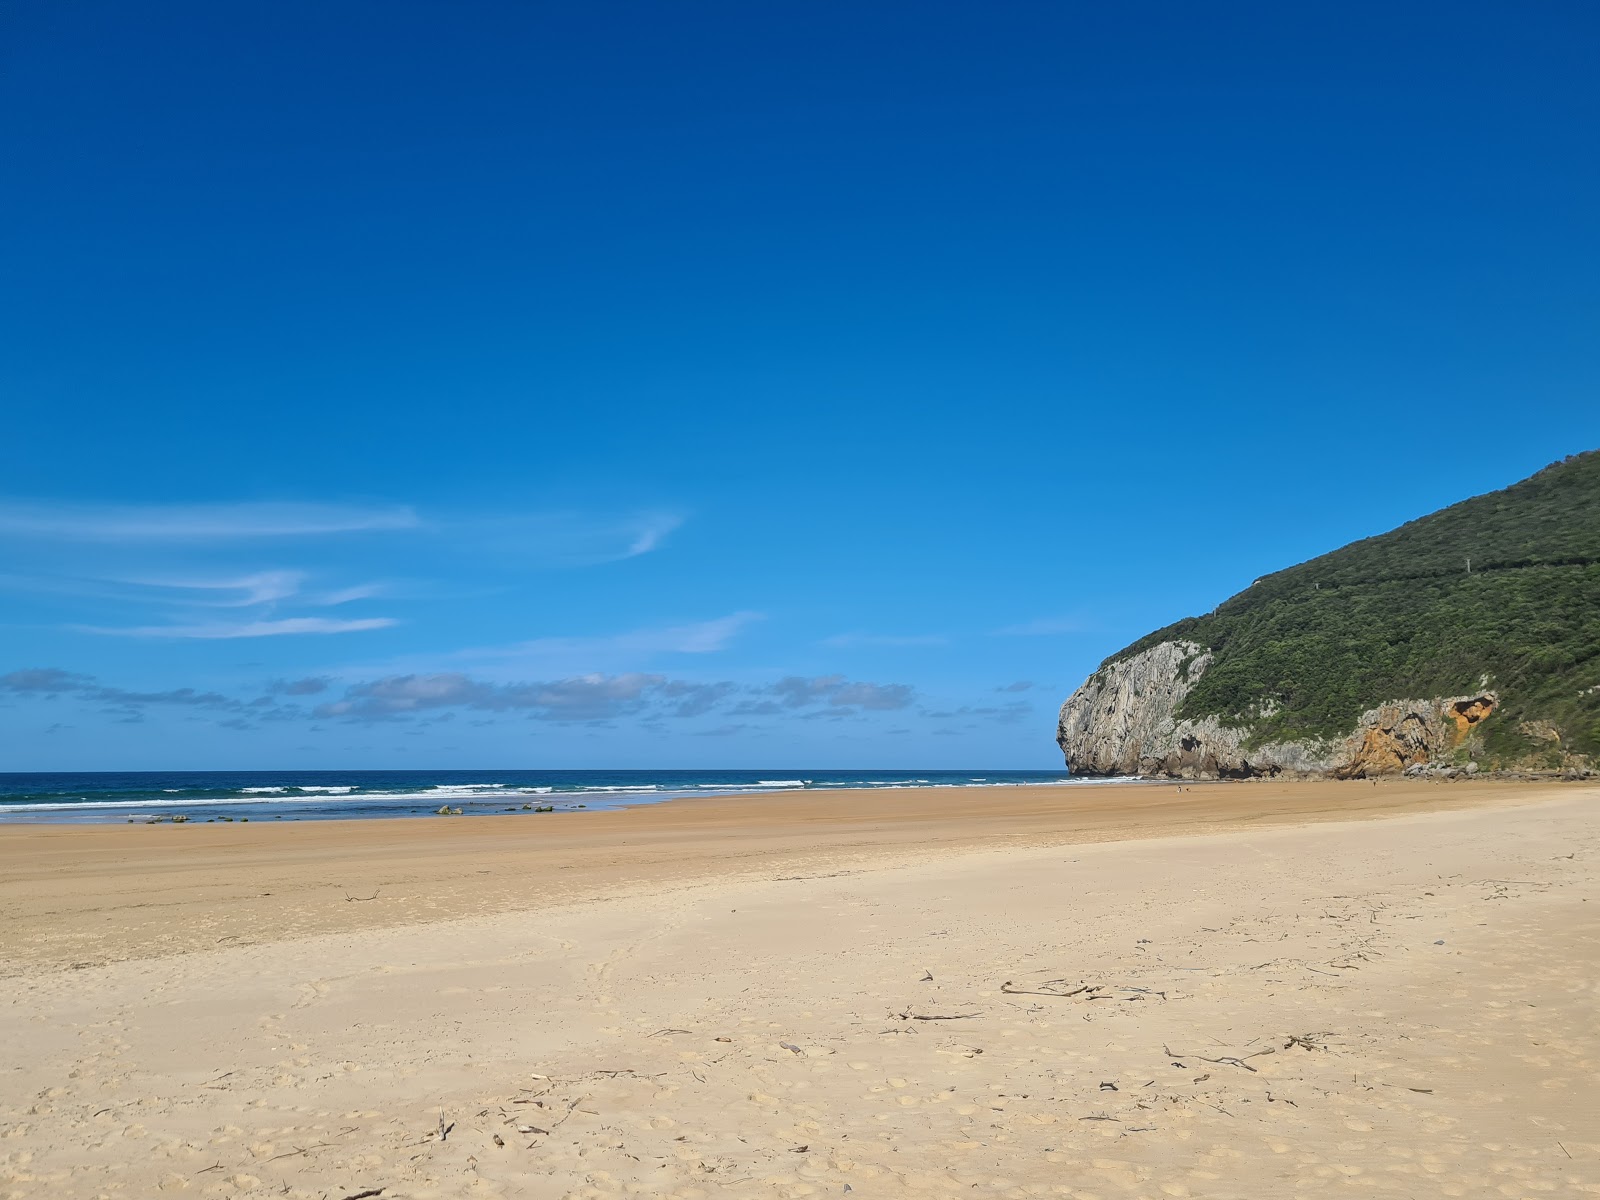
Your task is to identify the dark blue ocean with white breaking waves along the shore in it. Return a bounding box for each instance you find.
[0,768,1120,824]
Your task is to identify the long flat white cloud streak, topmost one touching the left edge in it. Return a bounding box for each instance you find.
[0,502,421,542]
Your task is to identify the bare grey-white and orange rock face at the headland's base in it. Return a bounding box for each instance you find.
[1056,642,1494,779]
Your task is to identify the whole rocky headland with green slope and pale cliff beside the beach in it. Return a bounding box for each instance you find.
[1056,451,1600,779]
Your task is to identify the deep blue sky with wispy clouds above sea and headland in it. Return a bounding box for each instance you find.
[0,0,1600,770]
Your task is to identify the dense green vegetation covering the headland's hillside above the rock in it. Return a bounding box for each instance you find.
[1110,451,1600,765]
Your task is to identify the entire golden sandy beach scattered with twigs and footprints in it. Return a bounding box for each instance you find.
[0,782,1600,1200]
